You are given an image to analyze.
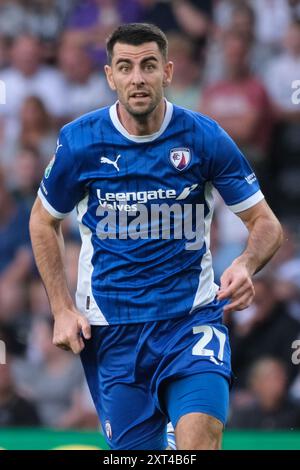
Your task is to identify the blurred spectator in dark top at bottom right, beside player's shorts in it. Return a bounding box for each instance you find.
[228,357,300,430]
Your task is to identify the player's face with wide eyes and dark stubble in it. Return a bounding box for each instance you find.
[105,42,173,117]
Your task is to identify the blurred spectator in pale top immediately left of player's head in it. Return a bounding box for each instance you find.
[59,38,114,120]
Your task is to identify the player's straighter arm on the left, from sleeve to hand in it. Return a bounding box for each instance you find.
[30,197,90,354]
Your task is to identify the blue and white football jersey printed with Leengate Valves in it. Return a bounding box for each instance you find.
[39,102,263,325]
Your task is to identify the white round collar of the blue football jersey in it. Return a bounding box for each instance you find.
[109,99,173,142]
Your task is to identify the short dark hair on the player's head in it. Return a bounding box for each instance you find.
[106,23,168,64]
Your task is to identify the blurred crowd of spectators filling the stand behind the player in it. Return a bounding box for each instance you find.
[0,0,300,430]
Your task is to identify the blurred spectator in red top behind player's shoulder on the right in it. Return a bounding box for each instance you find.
[200,30,271,178]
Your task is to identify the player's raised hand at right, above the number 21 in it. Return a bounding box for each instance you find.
[217,260,255,313]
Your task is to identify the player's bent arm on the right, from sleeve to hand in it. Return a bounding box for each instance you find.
[218,200,283,313]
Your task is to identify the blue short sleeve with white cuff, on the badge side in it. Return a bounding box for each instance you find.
[210,128,264,213]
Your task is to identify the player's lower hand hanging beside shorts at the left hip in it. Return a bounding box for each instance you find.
[53,309,91,354]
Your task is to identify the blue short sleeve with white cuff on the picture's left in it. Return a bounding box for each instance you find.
[38,130,85,219]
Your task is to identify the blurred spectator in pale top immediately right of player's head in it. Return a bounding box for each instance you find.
[166,34,200,109]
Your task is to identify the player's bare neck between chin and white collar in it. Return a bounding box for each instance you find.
[117,99,166,136]
